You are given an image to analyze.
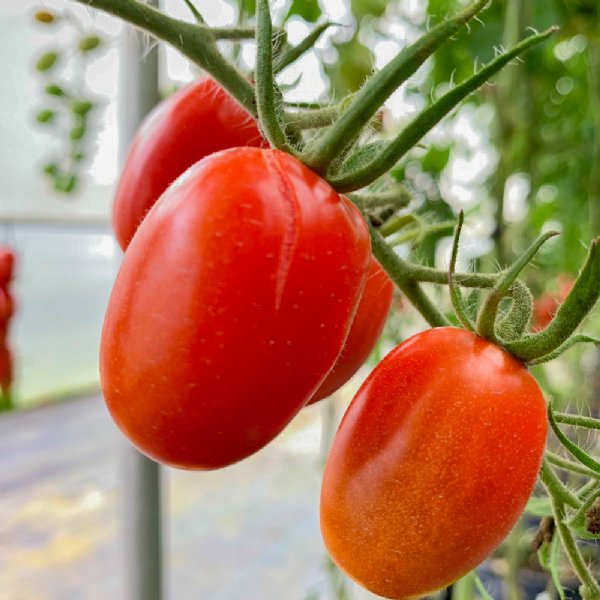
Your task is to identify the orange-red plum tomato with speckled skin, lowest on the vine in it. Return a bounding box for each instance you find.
[321,327,546,599]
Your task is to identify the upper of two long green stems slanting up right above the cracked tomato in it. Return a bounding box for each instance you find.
[304,0,489,175]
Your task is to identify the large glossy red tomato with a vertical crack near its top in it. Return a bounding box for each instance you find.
[100,148,370,469]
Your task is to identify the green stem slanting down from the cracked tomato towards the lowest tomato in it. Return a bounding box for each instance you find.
[369,225,449,327]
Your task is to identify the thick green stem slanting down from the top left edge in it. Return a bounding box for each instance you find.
[72,0,258,118]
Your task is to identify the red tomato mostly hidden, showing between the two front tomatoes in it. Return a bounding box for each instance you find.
[309,258,394,404]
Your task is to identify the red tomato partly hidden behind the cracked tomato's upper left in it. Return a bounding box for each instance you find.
[113,77,265,250]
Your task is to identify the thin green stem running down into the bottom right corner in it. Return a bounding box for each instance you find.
[540,461,600,598]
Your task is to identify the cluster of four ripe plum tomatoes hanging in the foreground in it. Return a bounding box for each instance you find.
[101,78,546,599]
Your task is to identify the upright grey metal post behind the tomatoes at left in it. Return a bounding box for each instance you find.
[118,5,163,600]
